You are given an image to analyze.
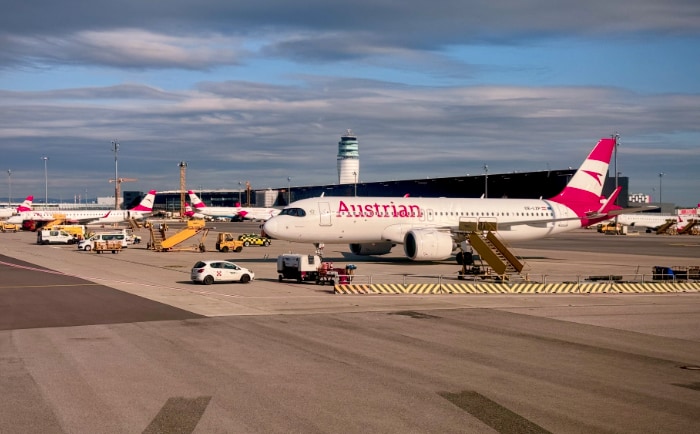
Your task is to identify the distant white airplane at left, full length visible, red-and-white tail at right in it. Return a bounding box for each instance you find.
[7,190,156,224]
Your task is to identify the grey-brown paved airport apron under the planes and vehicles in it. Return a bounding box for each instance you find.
[0,223,700,433]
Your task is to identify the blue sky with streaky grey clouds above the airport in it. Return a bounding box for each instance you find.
[0,0,700,206]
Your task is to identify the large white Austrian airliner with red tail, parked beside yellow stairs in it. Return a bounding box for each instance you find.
[263,138,628,261]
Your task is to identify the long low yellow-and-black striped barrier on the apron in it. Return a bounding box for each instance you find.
[335,281,700,295]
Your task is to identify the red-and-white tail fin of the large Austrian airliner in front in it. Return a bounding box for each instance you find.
[550,138,615,217]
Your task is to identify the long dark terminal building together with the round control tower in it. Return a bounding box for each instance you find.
[133,130,629,215]
